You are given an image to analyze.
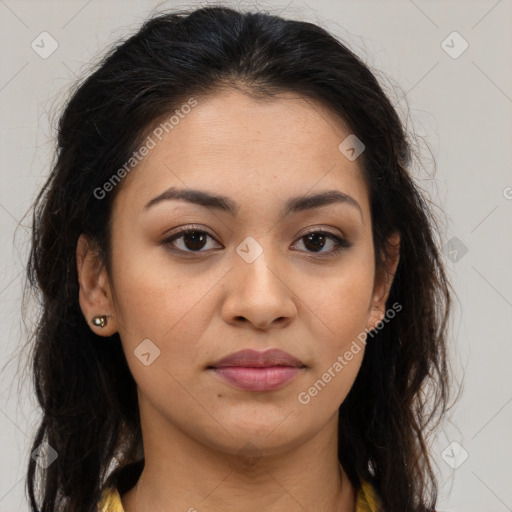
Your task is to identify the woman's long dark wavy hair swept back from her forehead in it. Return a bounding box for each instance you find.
[23,6,452,512]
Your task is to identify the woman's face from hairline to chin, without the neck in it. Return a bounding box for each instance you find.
[79,90,397,460]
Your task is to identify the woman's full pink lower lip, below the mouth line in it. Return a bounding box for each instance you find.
[209,366,303,391]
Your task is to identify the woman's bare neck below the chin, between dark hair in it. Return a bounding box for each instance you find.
[122,406,355,512]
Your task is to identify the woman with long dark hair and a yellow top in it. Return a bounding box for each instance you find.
[27,6,450,512]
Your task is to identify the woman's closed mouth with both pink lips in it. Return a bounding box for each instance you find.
[207,349,306,391]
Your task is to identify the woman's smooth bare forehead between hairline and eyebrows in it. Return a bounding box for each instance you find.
[116,88,367,215]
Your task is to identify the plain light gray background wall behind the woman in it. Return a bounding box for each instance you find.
[0,0,512,512]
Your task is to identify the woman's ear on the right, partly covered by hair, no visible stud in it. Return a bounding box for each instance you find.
[366,233,400,331]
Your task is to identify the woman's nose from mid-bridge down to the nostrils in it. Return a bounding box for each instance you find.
[222,246,297,330]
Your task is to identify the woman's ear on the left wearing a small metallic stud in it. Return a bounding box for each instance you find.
[76,234,117,336]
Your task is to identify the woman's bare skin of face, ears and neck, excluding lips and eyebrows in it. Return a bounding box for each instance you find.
[77,89,399,512]
